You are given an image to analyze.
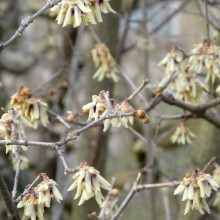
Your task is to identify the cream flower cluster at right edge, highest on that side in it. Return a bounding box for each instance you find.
[189,40,220,84]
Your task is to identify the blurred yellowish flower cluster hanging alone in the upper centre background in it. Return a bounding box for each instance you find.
[91,43,120,82]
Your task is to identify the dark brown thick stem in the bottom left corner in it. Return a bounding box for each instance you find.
[0,172,20,220]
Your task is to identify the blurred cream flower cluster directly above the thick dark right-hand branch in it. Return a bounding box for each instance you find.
[175,68,204,104]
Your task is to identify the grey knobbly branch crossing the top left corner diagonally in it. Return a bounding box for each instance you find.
[0,0,61,52]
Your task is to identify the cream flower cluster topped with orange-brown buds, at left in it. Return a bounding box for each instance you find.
[10,87,49,128]
